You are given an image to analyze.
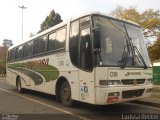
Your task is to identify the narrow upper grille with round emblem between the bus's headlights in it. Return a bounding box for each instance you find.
[121,79,145,85]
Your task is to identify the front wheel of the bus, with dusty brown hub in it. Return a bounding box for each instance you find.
[60,81,73,107]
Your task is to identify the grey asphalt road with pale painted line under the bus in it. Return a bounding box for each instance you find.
[0,80,160,120]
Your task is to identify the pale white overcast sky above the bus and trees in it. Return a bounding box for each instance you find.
[0,0,160,45]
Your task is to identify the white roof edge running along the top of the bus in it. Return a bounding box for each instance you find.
[9,12,140,50]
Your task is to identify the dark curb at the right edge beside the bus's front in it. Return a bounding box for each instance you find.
[132,100,160,108]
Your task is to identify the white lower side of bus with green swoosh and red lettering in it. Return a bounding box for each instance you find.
[7,52,80,101]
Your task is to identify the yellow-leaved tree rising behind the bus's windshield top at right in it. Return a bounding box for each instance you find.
[111,6,160,38]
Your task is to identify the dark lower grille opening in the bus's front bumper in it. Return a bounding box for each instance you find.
[122,89,144,99]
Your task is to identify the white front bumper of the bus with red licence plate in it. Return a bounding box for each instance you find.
[95,84,153,105]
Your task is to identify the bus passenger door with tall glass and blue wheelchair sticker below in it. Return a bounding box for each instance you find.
[79,27,95,103]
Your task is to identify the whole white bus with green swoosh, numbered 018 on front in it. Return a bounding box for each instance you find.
[7,13,153,106]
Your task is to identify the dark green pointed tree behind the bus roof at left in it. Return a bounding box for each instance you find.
[38,10,63,33]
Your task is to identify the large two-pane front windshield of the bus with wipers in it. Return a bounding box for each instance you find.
[93,16,151,68]
